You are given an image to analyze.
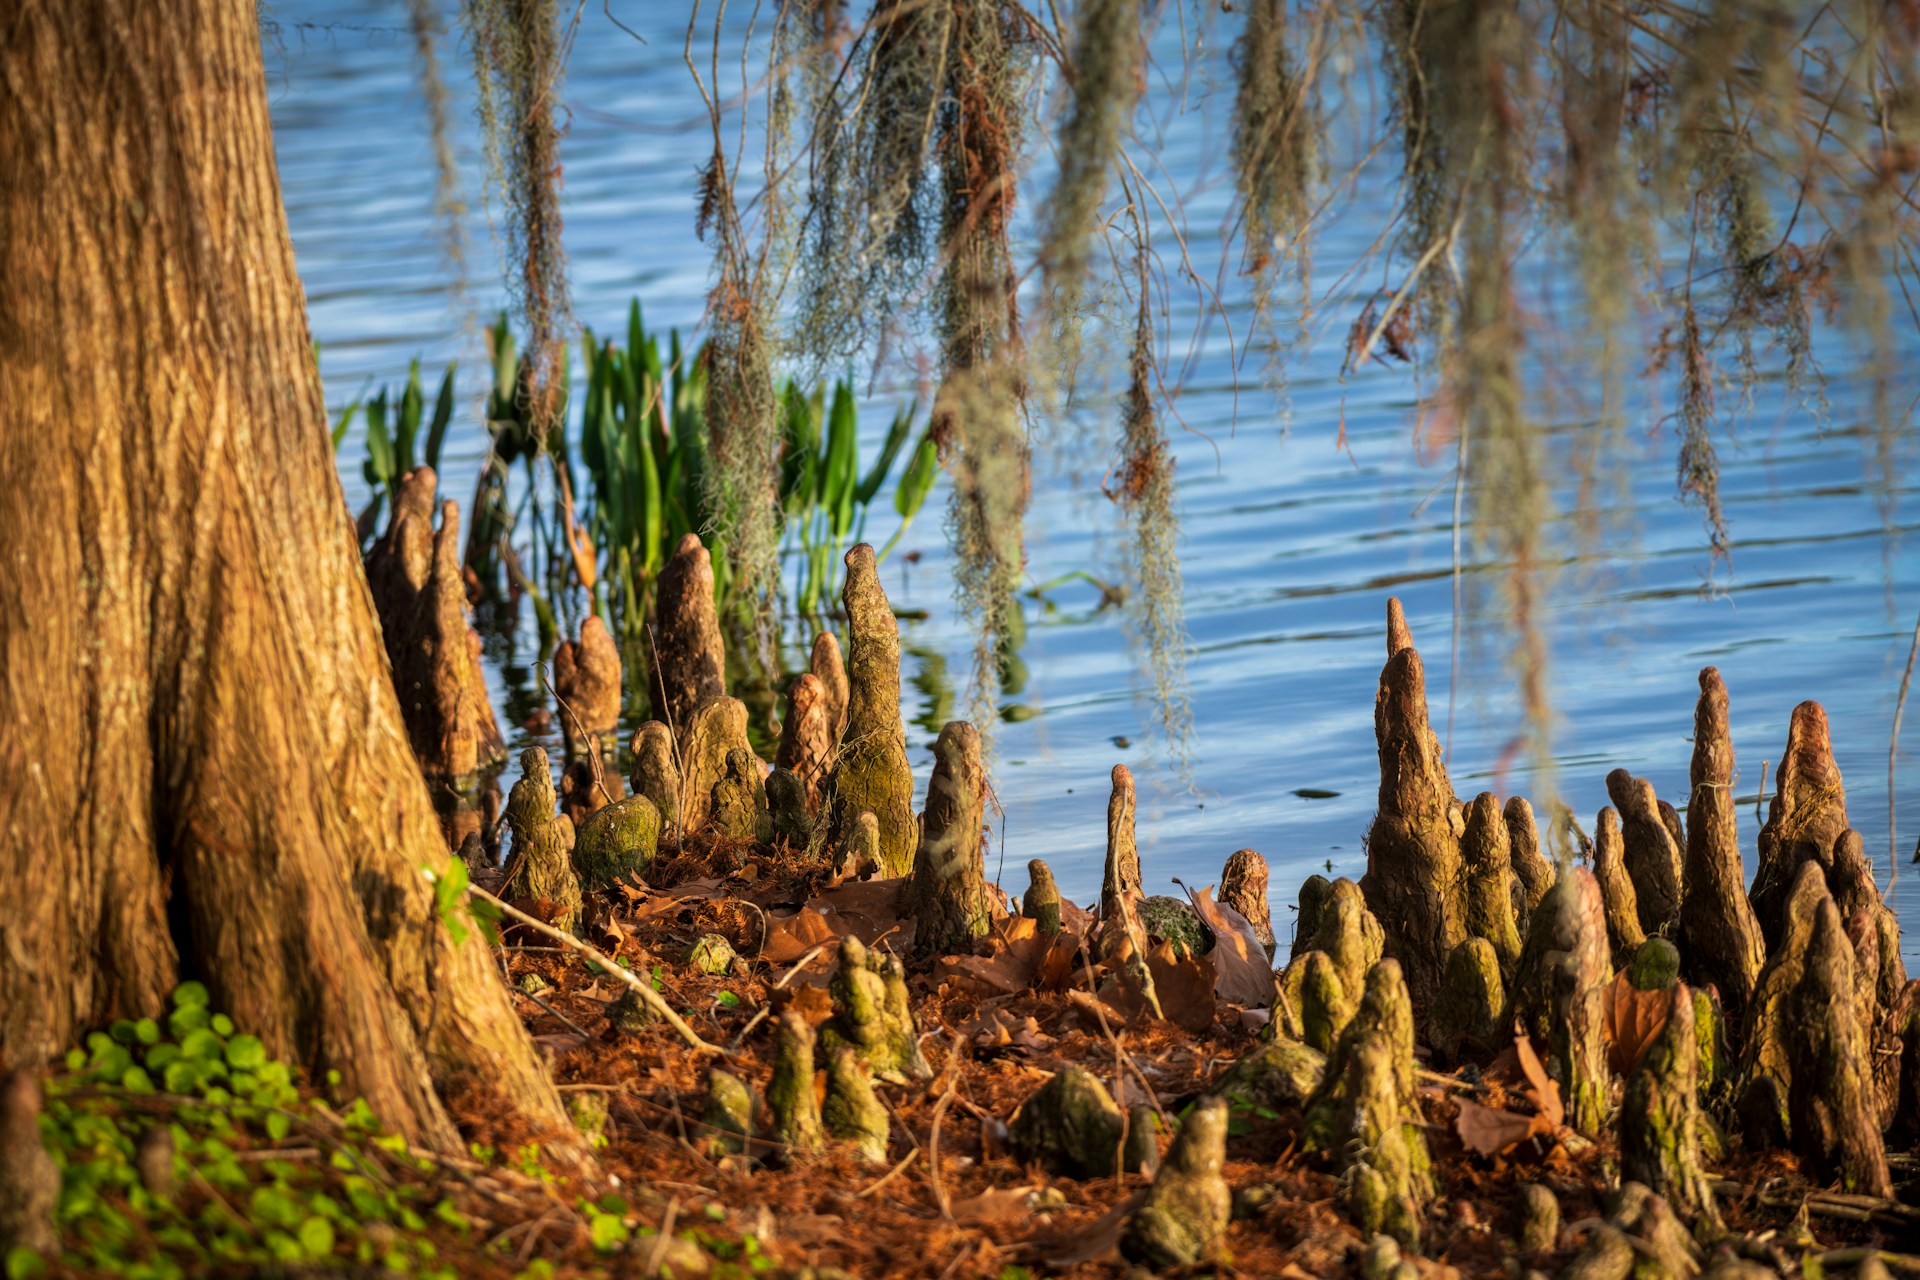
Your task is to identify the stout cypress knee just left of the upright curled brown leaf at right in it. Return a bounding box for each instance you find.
[1511,867,1613,1138]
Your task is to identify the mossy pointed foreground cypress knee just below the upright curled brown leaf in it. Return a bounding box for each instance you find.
[1620,983,1718,1222]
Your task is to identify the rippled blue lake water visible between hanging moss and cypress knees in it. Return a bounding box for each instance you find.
[267,0,1920,963]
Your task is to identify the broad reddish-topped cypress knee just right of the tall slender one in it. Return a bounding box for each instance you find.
[1753,702,1849,948]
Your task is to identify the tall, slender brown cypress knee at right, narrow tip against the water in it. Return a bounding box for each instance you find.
[1680,666,1766,1025]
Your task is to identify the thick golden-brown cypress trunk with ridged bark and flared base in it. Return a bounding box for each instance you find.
[0,0,564,1148]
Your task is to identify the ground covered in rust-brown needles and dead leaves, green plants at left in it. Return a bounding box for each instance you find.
[30,836,1920,1280]
